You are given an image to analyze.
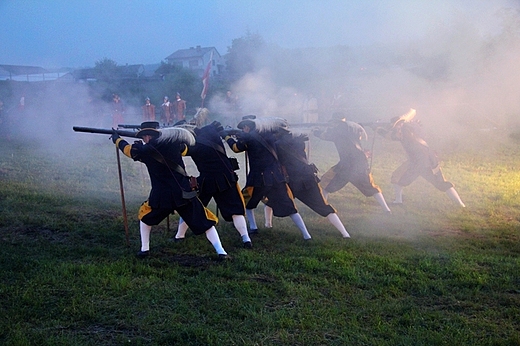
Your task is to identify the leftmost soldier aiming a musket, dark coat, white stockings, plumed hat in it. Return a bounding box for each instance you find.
[112,121,228,259]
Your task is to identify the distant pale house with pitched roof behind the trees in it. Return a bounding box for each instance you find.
[166,46,224,77]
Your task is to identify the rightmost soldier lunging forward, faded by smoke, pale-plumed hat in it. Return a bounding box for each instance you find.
[378,109,465,207]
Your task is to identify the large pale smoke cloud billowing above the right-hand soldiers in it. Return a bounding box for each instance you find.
[207,2,520,153]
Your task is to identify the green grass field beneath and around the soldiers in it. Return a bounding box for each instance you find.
[0,134,520,345]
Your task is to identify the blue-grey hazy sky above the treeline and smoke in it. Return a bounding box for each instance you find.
[0,0,519,68]
